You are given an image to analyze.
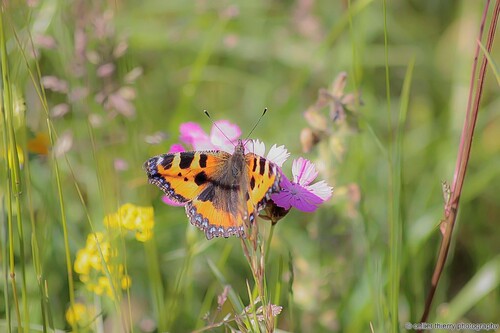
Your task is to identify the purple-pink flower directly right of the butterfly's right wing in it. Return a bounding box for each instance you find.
[271,157,333,212]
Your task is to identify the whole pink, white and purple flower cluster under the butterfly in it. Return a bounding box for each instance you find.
[163,120,333,223]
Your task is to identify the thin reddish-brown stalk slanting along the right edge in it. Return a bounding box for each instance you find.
[420,0,500,322]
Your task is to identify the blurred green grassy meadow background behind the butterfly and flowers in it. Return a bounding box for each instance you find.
[0,0,500,332]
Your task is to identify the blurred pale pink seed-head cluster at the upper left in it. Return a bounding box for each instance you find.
[34,2,142,122]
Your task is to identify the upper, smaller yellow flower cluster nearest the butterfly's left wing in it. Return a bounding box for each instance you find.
[104,203,155,242]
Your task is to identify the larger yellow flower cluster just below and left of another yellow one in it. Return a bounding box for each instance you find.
[74,232,131,299]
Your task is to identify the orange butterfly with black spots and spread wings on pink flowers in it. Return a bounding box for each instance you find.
[144,140,280,239]
